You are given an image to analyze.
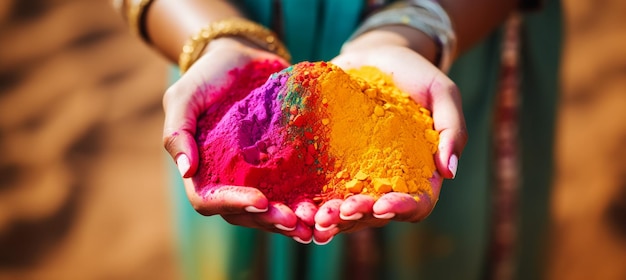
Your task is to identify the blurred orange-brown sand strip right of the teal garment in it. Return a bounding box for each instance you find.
[549,0,626,279]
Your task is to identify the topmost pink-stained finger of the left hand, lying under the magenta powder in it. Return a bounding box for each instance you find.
[183,178,269,216]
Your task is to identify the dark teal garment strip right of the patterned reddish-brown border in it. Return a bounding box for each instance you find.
[518,1,563,279]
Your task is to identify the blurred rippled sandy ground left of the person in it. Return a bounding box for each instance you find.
[0,0,179,279]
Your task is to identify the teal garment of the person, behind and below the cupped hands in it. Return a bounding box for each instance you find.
[175,0,561,280]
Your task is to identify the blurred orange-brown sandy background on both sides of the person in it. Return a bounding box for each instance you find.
[0,0,626,279]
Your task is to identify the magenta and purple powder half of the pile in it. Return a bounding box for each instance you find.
[194,61,325,204]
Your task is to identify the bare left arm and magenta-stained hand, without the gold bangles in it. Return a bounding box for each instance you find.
[130,0,315,241]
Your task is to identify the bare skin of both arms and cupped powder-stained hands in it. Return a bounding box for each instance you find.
[146,0,517,244]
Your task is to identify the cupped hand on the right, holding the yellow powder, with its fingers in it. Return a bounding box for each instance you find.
[314,45,467,244]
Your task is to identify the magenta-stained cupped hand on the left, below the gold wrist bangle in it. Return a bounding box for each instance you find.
[163,38,317,243]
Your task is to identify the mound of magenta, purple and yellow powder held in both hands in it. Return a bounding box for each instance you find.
[195,62,439,205]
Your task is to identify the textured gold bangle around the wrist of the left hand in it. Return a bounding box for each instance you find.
[178,18,291,73]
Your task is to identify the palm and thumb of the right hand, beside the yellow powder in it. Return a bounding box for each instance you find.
[332,45,467,174]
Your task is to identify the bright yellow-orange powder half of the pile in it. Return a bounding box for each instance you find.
[318,63,439,200]
